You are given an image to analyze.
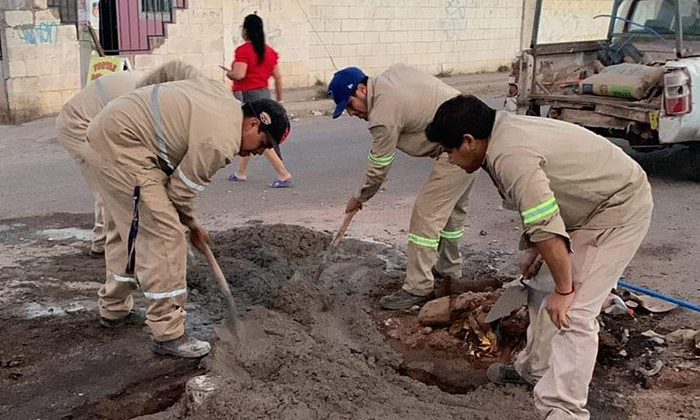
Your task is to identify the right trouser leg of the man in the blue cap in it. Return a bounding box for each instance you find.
[435,177,474,279]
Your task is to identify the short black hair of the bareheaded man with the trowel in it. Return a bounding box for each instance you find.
[425,95,496,149]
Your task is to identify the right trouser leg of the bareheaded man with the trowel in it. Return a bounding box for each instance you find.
[534,219,649,420]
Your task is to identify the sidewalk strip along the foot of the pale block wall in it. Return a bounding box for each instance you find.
[284,72,508,118]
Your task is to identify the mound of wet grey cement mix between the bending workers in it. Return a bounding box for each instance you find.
[172,225,520,418]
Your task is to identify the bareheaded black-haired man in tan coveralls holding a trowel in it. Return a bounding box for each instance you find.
[426,96,653,420]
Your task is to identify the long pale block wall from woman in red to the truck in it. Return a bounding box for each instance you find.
[224,0,612,87]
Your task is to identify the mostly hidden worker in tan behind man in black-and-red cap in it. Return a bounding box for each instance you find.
[56,61,200,255]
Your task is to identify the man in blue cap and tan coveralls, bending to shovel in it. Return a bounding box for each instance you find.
[329,64,475,310]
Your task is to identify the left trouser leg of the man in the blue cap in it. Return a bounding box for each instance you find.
[403,154,475,296]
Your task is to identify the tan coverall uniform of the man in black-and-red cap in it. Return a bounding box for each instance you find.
[88,78,243,341]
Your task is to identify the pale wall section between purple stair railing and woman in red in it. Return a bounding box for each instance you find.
[131,0,230,80]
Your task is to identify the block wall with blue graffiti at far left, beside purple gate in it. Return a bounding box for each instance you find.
[0,0,80,123]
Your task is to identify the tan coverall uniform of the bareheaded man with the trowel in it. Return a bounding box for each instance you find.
[485,112,653,420]
